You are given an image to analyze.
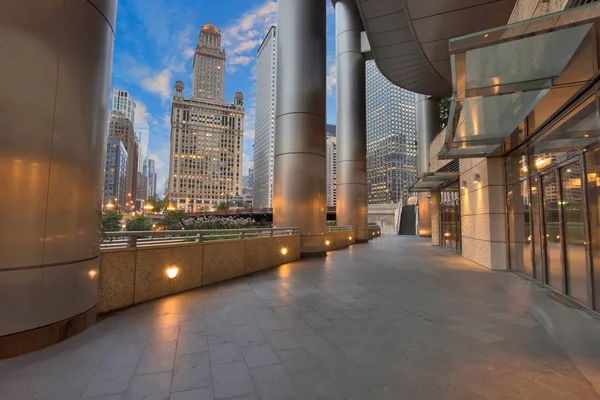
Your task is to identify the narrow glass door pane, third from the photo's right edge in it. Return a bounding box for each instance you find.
[542,171,565,293]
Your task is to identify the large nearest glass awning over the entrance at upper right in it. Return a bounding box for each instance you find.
[439,3,600,159]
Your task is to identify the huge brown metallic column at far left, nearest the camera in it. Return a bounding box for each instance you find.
[0,0,117,358]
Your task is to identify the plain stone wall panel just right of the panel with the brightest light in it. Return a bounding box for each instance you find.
[202,240,246,285]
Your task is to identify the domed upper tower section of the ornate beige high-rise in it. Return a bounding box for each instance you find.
[190,23,225,101]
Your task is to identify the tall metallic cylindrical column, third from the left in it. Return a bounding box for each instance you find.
[335,0,369,242]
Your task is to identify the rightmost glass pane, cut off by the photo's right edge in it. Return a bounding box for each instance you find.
[586,147,600,311]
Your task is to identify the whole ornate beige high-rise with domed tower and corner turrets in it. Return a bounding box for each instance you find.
[168,24,245,211]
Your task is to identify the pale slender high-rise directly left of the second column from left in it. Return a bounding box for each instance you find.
[253,26,277,208]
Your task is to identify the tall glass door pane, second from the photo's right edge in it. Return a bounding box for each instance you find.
[560,162,587,304]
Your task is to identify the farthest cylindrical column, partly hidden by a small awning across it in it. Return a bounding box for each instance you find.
[416,94,440,236]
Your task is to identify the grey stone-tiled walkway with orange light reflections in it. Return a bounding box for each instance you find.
[0,237,600,400]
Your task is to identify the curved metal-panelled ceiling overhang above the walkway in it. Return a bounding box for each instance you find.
[356,0,516,98]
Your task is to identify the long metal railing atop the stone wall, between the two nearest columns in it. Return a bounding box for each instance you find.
[100,228,299,249]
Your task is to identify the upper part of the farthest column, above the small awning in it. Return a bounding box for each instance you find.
[416,94,440,175]
